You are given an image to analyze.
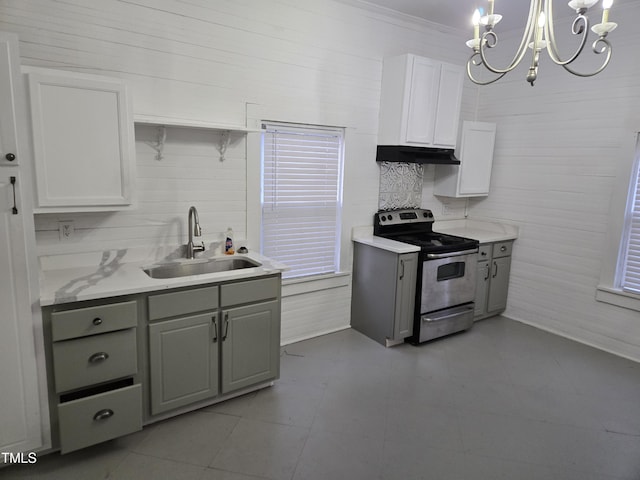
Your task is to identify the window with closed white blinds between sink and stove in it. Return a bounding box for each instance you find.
[261,123,344,278]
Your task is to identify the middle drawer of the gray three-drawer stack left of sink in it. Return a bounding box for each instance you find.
[53,329,138,392]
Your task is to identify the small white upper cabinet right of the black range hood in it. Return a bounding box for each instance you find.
[433,122,496,197]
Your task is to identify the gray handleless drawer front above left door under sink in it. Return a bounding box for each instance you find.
[149,285,219,320]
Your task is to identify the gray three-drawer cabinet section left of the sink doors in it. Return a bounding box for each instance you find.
[43,300,143,453]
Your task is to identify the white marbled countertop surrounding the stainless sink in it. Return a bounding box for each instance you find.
[39,249,287,306]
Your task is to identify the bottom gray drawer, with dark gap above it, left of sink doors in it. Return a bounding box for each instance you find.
[58,385,142,453]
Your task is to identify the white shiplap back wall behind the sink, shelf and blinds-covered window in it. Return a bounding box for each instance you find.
[0,0,476,342]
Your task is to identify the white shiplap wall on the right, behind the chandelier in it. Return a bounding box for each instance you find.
[470,2,640,360]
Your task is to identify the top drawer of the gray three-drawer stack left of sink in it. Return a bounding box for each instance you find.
[51,301,138,342]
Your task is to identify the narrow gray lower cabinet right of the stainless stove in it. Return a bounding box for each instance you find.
[474,241,513,320]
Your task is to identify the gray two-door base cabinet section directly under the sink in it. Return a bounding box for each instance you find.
[148,275,281,416]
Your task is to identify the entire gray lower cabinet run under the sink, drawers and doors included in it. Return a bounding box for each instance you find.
[43,274,281,453]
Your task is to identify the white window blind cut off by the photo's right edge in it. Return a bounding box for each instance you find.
[620,141,640,294]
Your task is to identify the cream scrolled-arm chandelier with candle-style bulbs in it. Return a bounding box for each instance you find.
[467,0,618,86]
